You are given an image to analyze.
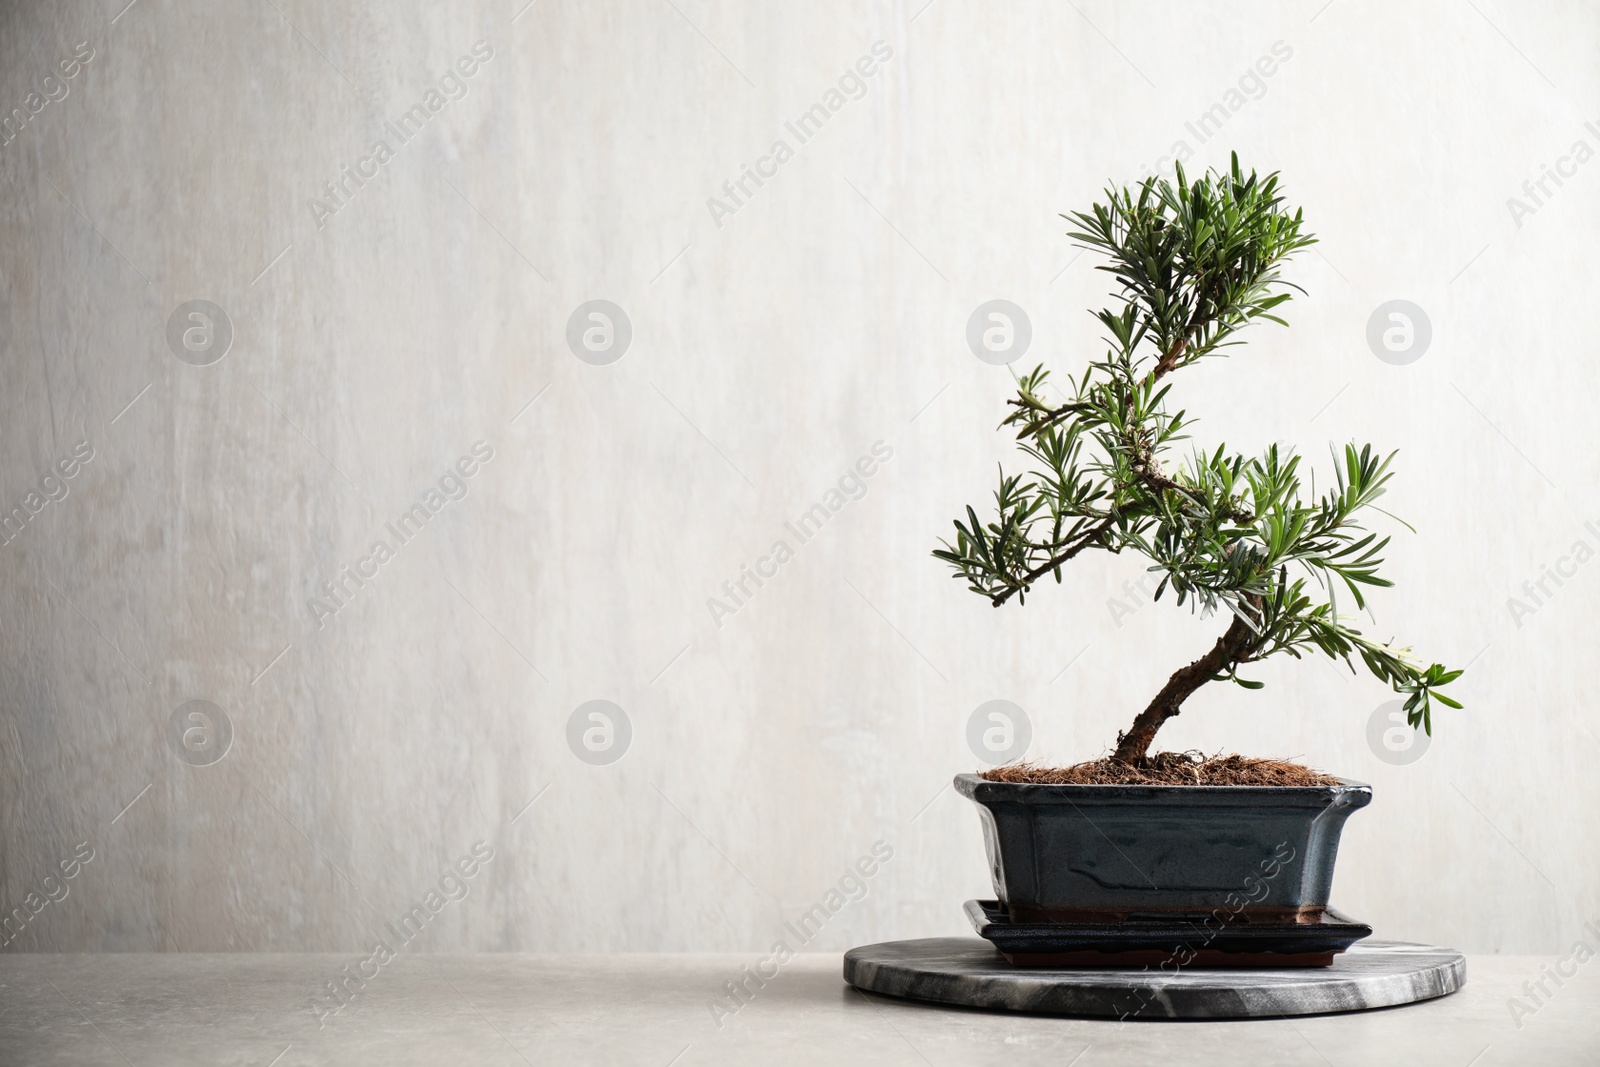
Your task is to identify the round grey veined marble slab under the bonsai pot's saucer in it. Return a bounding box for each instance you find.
[845,937,1467,1019]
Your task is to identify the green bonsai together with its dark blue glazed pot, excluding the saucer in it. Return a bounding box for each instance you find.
[934,155,1461,953]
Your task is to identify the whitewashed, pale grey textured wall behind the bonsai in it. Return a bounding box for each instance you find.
[0,0,1600,952]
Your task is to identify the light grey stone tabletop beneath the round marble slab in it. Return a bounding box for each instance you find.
[0,953,1600,1067]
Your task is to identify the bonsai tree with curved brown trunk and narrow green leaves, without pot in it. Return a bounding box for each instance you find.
[934,155,1461,766]
